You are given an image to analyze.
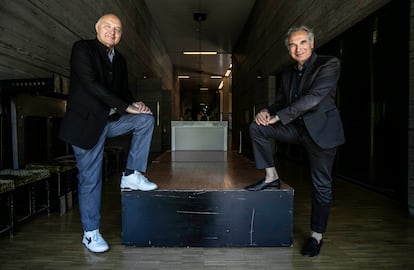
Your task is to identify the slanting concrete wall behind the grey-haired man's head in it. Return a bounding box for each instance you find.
[233,0,390,100]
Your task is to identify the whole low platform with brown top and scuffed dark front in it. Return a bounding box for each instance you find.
[121,151,294,247]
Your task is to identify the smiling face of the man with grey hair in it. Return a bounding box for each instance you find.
[288,30,314,67]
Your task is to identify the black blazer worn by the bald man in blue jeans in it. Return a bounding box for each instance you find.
[59,39,133,149]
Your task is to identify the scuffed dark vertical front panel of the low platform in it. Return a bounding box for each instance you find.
[121,189,294,247]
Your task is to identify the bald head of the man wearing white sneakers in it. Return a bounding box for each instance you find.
[95,15,122,48]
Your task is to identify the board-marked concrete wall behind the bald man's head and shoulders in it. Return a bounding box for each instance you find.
[0,0,175,109]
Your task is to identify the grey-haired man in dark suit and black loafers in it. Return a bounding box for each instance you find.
[246,26,345,257]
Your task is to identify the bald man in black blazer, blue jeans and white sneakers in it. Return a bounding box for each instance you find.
[60,14,157,252]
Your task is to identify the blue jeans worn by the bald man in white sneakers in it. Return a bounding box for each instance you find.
[72,114,154,231]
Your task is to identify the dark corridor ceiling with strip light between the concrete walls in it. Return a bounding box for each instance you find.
[145,0,255,96]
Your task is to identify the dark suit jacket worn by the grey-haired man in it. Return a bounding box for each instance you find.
[268,53,345,148]
